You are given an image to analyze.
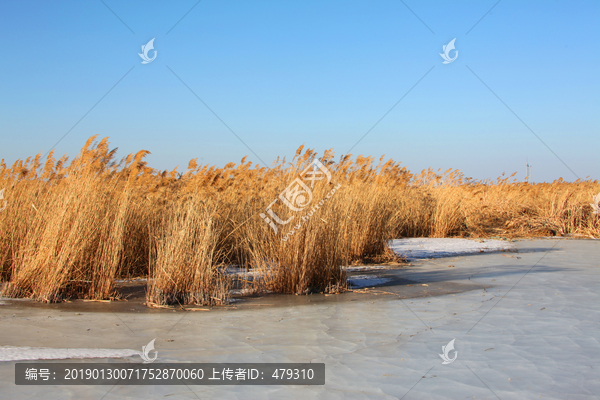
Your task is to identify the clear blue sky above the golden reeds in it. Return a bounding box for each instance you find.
[0,0,600,181]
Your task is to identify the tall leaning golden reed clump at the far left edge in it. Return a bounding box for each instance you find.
[2,139,148,302]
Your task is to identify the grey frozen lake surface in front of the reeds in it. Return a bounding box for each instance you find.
[0,239,600,400]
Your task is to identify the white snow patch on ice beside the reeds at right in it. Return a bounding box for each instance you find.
[390,238,513,260]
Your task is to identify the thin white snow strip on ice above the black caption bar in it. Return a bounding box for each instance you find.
[0,346,141,361]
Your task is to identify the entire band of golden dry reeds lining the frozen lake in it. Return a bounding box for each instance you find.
[0,136,600,305]
